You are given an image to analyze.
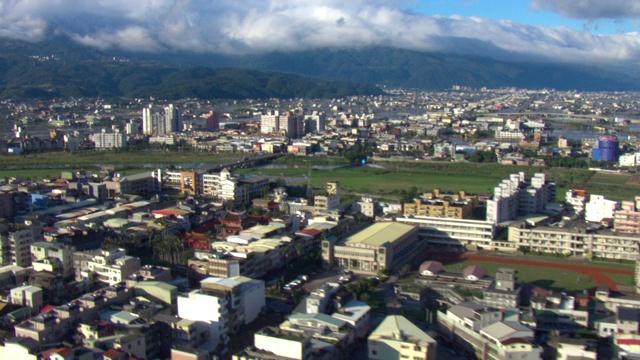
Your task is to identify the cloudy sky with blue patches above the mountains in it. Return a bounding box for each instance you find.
[0,0,640,66]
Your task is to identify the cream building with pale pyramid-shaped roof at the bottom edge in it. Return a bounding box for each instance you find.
[367,315,437,360]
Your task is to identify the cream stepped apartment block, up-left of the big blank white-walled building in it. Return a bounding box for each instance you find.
[73,249,141,285]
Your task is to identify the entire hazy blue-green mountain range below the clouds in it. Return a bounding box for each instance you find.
[0,36,640,99]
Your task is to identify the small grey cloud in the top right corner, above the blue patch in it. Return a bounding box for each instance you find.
[529,0,640,20]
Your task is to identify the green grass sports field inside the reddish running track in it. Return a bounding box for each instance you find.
[444,261,596,291]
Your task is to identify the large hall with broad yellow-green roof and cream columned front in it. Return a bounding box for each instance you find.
[322,222,424,273]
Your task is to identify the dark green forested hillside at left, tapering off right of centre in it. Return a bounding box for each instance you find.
[0,37,382,100]
